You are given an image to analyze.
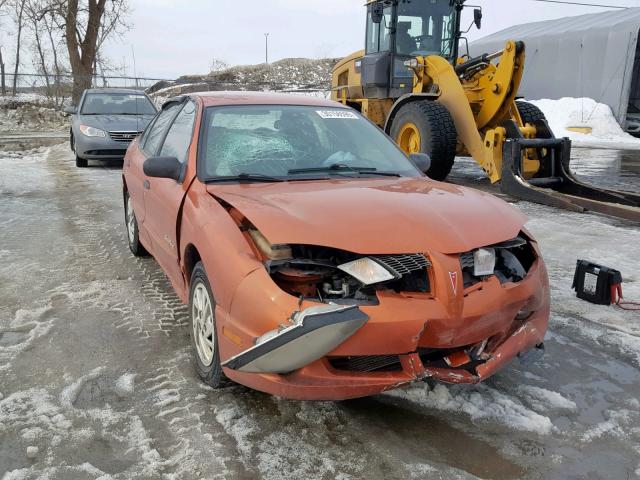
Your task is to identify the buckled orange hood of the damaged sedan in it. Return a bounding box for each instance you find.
[207,178,526,254]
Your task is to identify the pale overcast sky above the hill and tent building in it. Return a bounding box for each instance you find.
[5,0,640,79]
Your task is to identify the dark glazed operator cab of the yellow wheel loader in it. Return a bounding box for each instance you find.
[361,0,462,98]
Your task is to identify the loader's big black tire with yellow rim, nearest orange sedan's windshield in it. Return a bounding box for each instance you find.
[391,100,458,181]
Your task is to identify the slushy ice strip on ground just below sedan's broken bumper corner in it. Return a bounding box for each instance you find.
[386,383,554,435]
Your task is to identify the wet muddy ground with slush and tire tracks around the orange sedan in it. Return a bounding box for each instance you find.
[0,145,640,480]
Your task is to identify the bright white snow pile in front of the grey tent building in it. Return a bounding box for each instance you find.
[529,97,640,149]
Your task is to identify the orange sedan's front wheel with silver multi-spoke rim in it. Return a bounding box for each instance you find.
[189,262,230,388]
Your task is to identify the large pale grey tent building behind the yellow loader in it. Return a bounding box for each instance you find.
[470,8,640,126]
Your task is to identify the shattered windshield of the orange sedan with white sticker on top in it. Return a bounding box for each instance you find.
[199,105,421,179]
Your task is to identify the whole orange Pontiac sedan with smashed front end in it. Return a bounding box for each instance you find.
[123,92,549,400]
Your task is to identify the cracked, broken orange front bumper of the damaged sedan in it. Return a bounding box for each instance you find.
[217,256,549,400]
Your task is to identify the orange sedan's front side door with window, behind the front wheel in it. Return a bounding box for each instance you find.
[144,100,197,288]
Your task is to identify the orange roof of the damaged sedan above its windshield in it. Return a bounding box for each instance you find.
[188,91,348,108]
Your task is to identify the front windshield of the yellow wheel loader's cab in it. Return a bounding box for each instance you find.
[396,0,455,58]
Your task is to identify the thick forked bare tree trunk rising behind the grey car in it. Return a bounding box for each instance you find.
[57,0,129,103]
